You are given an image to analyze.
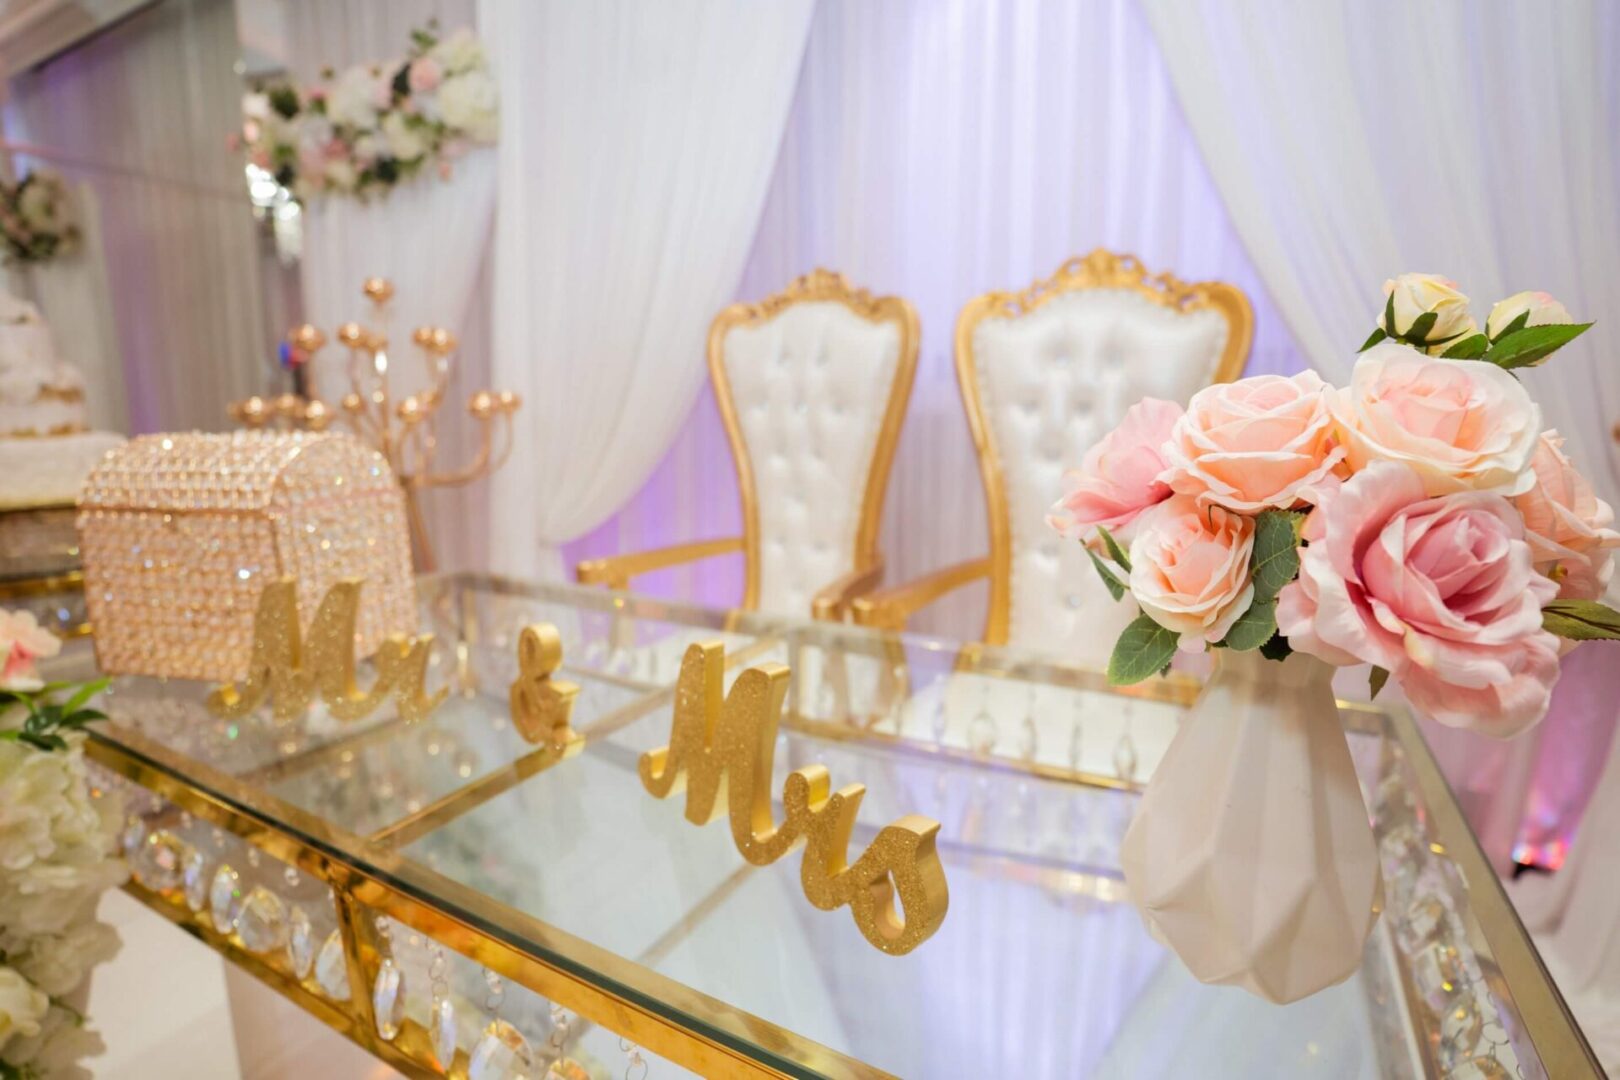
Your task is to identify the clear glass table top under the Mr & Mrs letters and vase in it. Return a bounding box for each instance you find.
[63,576,1583,1078]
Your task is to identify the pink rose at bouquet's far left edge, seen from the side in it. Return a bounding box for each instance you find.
[1047,398,1181,539]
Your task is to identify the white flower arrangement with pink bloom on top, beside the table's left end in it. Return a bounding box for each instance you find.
[0,610,128,1080]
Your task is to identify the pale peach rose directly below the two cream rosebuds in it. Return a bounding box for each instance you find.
[1328,342,1541,495]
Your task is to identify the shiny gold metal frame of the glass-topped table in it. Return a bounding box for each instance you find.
[72,575,1604,1080]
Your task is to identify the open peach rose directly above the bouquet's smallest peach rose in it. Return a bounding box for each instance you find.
[1165,371,1345,513]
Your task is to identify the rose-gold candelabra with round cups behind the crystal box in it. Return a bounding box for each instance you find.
[228,277,523,570]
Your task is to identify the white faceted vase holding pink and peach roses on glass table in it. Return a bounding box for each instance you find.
[1048,274,1620,1001]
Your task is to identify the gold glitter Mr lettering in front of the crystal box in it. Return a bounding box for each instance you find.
[207,576,449,722]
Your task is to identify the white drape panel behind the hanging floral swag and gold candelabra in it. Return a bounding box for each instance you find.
[285,0,492,568]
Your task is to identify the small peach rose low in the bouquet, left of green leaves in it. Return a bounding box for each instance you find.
[1131,495,1254,653]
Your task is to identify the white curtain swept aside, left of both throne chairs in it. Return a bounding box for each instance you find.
[478,0,810,575]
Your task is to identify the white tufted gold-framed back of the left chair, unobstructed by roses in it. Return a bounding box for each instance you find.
[708,270,917,615]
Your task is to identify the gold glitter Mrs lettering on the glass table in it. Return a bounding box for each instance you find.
[638,641,949,955]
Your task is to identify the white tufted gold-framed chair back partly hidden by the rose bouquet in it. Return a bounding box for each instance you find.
[956,249,1254,665]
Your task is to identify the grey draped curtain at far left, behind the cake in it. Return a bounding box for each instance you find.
[5,0,274,431]
